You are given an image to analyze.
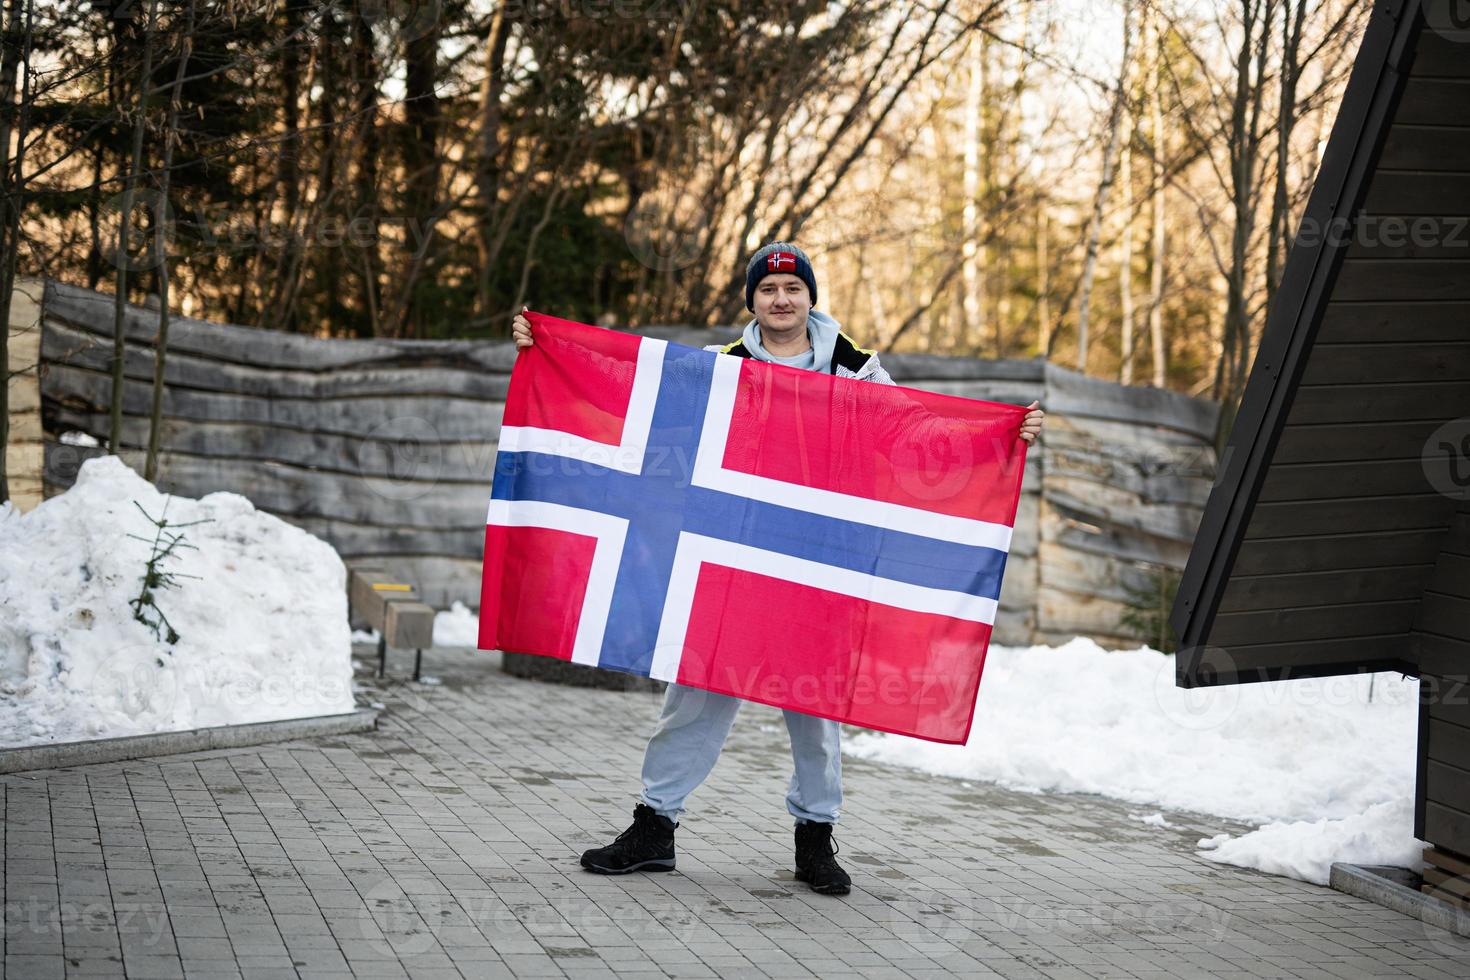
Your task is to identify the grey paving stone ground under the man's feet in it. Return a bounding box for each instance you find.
[0,651,1470,980]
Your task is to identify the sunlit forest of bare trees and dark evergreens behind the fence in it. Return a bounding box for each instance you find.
[0,0,1372,498]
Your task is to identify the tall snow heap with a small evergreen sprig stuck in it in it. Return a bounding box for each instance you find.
[0,457,353,746]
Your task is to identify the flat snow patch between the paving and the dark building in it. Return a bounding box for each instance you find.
[847,638,1419,883]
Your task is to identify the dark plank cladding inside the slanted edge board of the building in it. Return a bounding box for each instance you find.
[1210,29,1470,676]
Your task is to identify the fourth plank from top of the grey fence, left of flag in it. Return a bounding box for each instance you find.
[50,407,498,486]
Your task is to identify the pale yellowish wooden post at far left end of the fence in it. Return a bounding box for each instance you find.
[4,279,44,511]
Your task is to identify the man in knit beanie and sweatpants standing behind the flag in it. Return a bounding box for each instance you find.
[513,241,1044,895]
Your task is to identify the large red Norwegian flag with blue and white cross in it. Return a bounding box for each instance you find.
[479,313,1026,742]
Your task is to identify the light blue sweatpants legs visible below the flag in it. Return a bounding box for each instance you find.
[641,683,842,823]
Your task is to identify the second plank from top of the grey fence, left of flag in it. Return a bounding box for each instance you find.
[44,322,510,401]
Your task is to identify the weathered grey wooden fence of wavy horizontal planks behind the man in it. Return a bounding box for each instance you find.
[11,282,1216,645]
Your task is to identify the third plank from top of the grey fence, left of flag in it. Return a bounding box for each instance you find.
[41,364,504,442]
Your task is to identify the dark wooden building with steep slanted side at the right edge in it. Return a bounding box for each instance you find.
[1172,0,1470,898]
